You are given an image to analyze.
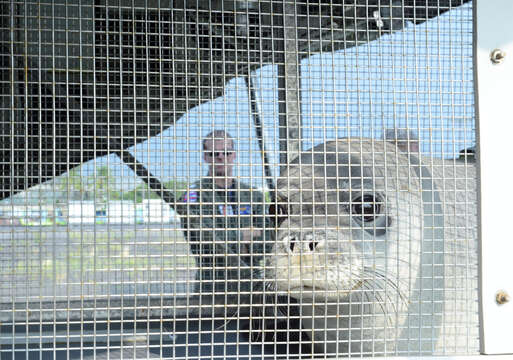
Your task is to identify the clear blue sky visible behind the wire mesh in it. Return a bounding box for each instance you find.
[69,4,475,190]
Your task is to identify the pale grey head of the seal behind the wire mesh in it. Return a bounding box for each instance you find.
[265,139,423,353]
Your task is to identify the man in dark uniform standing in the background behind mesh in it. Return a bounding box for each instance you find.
[179,130,271,295]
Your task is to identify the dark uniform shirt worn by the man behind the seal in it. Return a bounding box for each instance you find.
[177,178,271,292]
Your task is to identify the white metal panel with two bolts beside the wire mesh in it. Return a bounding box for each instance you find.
[474,0,513,354]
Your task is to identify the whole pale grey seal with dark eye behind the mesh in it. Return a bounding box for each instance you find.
[258,139,479,356]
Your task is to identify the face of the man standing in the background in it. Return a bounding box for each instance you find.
[203,140,235,176]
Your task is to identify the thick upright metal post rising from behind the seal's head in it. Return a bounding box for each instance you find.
[278,1,301,171]
